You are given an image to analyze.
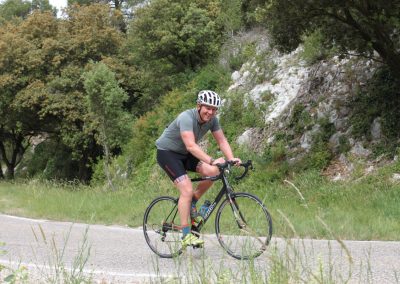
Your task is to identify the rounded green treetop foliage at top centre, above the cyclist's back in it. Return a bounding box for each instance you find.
[125,0,223,108]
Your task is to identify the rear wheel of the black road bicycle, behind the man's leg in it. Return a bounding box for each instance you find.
[143,196,182,258]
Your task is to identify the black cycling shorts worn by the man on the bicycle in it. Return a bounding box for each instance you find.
[157,149,199,181]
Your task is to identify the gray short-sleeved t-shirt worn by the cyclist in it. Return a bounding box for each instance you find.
[156,109,220,154]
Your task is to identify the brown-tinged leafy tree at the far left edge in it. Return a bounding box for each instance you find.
[0,13,57,178]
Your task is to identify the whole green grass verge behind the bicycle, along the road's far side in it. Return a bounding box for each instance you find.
[0,160,400,240]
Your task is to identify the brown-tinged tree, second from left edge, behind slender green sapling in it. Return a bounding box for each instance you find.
[37,4,132,182]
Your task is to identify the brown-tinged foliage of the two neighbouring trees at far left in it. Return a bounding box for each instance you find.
[0,5,130,180]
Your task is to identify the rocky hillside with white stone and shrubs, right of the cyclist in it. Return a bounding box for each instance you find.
[219,30,398,180]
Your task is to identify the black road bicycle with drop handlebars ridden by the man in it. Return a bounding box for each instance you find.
[143,160,272,259]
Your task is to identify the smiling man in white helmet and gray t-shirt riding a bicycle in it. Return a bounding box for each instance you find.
[156,90,241,248]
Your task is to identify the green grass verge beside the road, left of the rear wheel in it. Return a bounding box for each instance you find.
[0,179,156,226]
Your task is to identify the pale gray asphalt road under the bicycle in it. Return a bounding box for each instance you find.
[0,214,400,283]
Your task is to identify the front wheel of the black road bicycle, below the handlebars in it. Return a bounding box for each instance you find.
[215,193,272,259]
